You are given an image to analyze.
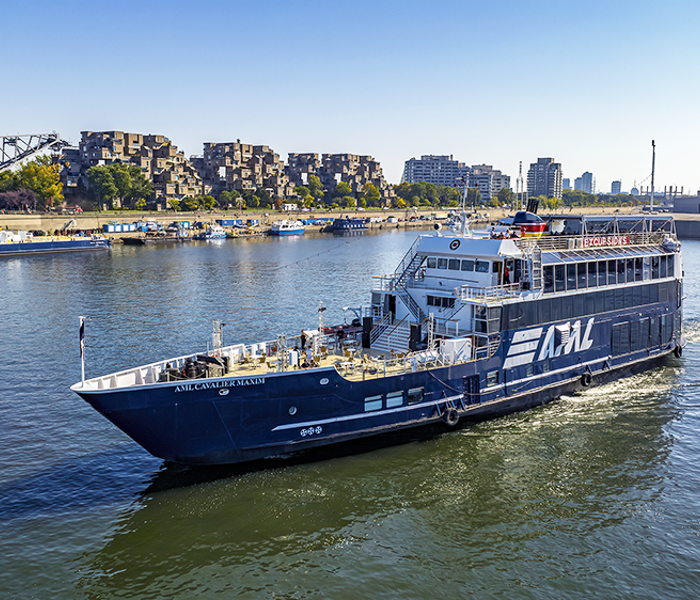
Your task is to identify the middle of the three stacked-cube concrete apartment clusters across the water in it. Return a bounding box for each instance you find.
[194,139,294,198]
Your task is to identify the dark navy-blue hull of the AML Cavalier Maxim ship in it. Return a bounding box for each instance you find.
[74,299,681,465]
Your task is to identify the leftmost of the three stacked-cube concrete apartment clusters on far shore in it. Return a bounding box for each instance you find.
[59,131,209,208]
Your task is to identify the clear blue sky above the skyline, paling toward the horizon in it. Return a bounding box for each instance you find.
[5,0,700,193]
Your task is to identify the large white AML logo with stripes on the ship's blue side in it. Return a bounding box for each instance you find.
[503,317,595,369]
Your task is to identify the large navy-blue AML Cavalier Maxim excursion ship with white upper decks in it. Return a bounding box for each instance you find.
[71,215,684,465]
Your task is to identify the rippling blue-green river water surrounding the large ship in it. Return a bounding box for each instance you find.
[0,230,700,600]
